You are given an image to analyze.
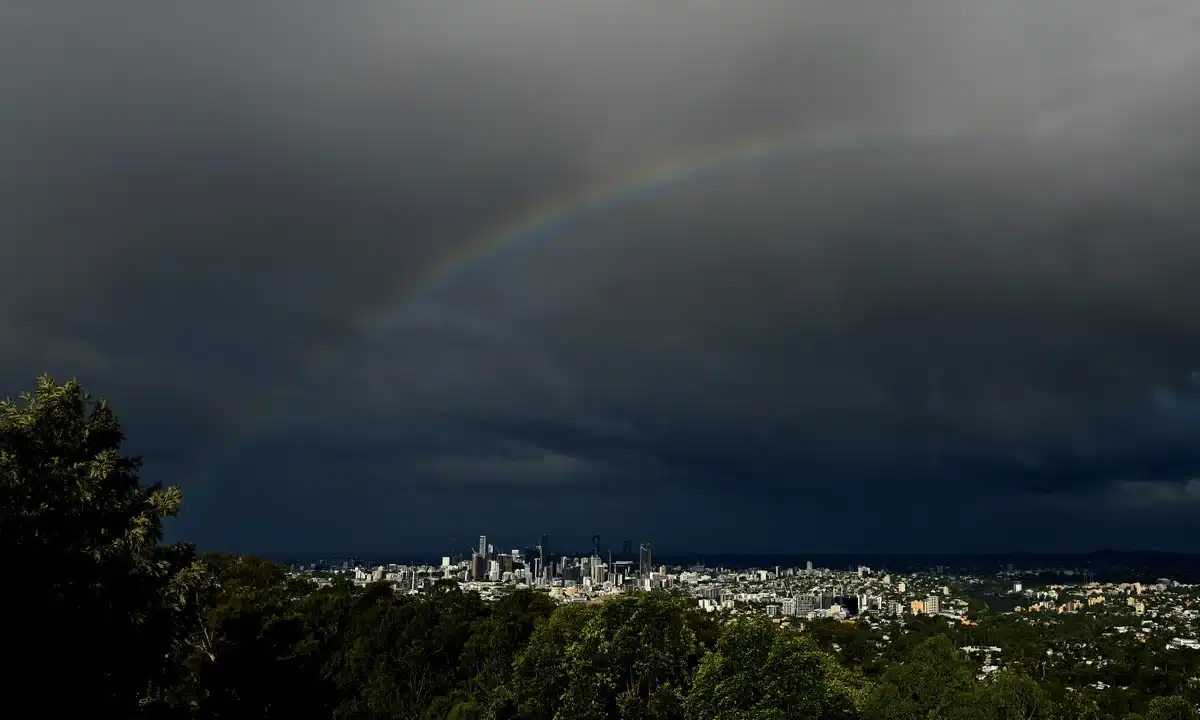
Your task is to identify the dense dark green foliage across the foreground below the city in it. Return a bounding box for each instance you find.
[0,378,1200,720]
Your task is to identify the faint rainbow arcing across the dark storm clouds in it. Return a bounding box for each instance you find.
[200,128,948,476]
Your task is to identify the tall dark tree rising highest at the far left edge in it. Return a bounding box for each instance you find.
[0,377,192,716]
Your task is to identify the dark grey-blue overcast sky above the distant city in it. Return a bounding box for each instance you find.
[0,0,1200,553]
